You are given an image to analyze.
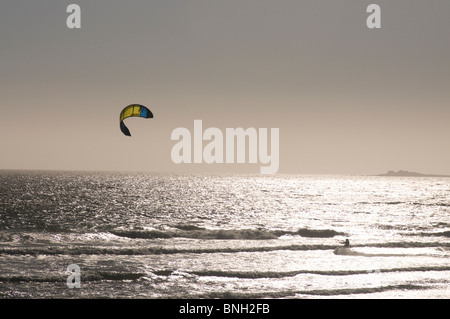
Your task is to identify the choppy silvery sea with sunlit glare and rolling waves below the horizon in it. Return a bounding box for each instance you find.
[0,171,450,298]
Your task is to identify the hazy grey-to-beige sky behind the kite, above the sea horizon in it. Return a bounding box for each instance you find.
[0,0,450,174]
